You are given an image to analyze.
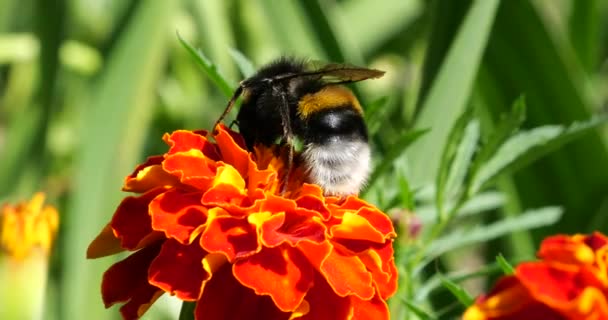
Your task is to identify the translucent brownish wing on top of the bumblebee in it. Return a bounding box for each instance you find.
[279,62,384,84]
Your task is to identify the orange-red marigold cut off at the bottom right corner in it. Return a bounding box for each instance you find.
[463,232,608,320]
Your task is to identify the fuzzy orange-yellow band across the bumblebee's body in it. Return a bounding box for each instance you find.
[298,86,363,118]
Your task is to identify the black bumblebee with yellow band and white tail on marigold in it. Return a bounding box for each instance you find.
[216,57,384,196]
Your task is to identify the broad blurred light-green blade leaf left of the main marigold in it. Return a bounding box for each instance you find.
[57,1,177,319]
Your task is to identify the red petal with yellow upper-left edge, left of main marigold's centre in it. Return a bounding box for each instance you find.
[200,208,261,263]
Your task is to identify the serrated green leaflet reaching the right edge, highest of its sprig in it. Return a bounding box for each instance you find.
[469,115,608,194]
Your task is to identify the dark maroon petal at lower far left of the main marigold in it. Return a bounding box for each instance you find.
[101,243,160,308]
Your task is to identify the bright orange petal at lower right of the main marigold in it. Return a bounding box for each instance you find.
[319,248,375,300]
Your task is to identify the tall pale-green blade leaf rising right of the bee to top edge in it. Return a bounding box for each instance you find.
[407,0,499,187]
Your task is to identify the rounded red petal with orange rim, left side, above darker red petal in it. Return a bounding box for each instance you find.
[149,189,207,244]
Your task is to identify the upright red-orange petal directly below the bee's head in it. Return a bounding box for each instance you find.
[215,126,253,176]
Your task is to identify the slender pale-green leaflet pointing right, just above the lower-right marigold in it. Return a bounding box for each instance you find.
[426,207,562,260]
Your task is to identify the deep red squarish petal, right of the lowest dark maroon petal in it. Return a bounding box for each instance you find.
[148,239,210,301]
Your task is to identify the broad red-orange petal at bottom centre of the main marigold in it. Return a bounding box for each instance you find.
[233,246,314,312]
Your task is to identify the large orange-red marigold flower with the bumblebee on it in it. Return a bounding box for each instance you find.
[87,126,397,320]
